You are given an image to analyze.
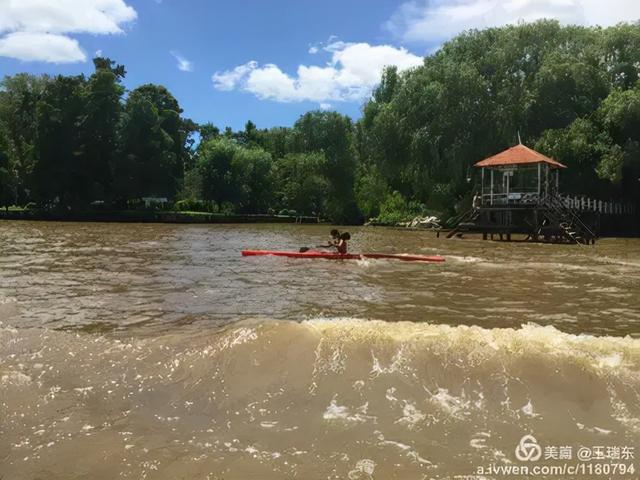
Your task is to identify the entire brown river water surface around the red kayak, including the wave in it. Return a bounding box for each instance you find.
[0,222,640,480]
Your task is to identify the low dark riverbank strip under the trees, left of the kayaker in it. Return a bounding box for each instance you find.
[0,209,323,224]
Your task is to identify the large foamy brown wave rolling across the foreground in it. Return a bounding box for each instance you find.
[0,318,640,480]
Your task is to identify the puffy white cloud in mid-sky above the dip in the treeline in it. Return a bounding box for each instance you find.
[212,41,422,104]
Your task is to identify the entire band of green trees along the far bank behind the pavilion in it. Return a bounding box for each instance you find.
[0,21,640,222]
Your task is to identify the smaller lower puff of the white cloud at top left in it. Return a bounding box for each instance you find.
[0,32,87,63]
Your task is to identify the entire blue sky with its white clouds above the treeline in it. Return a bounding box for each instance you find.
[0,0,640,129]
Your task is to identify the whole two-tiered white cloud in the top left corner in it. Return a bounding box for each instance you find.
[0,0,137,63]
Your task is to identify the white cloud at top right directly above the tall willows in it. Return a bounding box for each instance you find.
[385,0,640,42]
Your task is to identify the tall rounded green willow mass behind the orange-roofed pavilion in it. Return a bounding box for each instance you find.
[354,20,640,219]
